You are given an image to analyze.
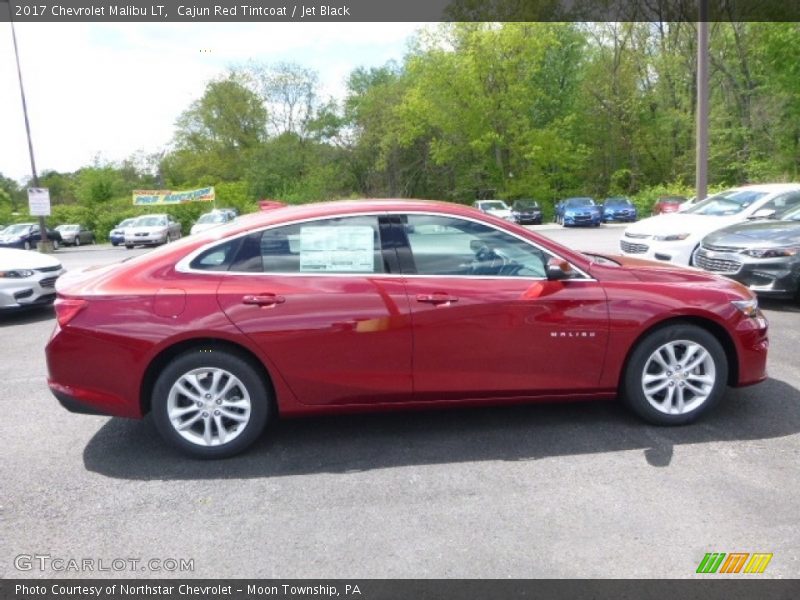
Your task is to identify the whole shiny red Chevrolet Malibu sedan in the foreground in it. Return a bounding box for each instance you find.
[46,200,767,458]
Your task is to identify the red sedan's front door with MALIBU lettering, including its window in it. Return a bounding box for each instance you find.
[397,214,608,400]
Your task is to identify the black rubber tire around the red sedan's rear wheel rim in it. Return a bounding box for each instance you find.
[152,347,272,459]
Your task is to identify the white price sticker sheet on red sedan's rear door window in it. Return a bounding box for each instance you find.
[300,225,375,273]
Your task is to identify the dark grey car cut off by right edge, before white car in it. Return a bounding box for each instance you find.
[694,207,800,299]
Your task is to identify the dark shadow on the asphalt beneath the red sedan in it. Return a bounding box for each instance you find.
[83,379,800,480]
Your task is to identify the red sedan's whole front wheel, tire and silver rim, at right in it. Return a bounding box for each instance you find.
[622,324,728,425]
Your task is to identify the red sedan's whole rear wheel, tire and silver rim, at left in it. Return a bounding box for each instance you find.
[152,348,271,458]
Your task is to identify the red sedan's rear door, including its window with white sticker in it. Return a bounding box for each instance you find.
[217,216,412,405]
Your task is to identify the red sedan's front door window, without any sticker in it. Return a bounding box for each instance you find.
[403,215,552,278]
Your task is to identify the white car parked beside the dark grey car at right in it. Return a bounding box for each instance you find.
[619,183,800,265]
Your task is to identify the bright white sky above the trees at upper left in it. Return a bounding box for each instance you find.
[0,23,423,182]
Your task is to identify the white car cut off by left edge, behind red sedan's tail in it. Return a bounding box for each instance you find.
[0,248,64,310]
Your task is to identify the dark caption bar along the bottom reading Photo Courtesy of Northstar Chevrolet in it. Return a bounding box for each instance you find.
[0,575,800,600]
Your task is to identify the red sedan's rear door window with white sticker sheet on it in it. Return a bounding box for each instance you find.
[228,216,388,274]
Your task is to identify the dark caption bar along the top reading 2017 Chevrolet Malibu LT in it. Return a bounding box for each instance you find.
[0,0,800,23]
